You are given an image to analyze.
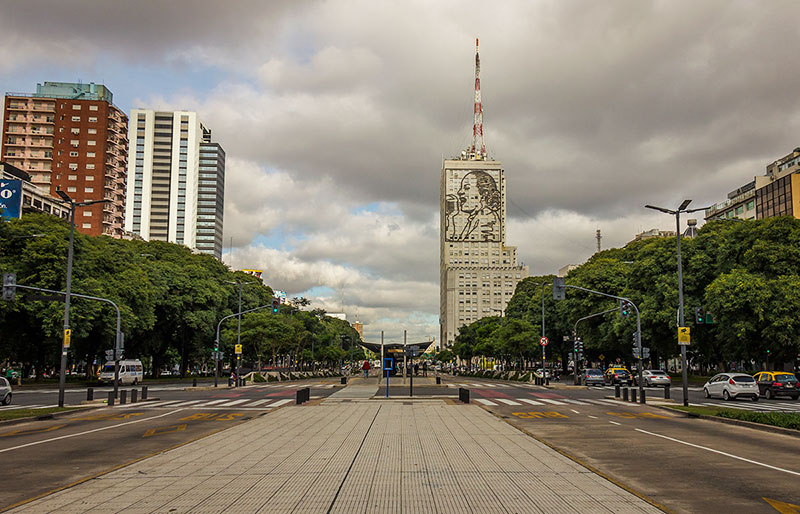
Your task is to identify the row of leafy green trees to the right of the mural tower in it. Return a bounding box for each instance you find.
[452,217,800,371]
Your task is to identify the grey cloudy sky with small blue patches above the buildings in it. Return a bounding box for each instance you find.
[0,0,800,339]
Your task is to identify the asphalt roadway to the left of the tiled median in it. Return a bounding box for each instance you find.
[0,379,342,510]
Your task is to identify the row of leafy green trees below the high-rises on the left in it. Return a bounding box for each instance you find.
[0,214,362,376]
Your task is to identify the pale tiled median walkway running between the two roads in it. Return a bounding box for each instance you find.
[12,400,660,514]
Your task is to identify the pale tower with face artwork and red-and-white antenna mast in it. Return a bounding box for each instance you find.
[439,41,528,346]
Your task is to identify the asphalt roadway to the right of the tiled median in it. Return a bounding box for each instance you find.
[445,377,800,514]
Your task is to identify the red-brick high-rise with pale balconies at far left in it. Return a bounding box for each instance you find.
[2,82,128,237]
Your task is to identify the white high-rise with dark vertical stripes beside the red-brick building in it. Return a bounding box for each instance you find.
[125,109,225,258]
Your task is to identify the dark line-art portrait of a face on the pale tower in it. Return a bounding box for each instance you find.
[445,171,502,242]
